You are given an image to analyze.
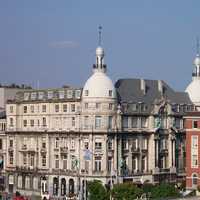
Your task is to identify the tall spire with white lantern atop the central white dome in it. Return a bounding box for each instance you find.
[93,26,106,73]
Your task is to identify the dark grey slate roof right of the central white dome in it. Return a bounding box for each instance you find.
[115,79,192,104]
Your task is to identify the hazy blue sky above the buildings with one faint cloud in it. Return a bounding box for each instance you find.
[0,0,200,91]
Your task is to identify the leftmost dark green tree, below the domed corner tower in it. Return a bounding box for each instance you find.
[87,180,109,200]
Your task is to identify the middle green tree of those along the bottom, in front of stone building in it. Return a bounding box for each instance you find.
[111,183,142,200]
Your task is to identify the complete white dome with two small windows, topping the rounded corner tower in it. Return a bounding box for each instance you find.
[82,72,116,98]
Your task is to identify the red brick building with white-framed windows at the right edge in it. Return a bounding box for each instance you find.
[184,111,200,189]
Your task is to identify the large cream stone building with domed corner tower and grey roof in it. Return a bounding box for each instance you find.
[0,39,194,199]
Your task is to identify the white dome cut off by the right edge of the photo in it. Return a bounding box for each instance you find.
[185,77,200,105]
